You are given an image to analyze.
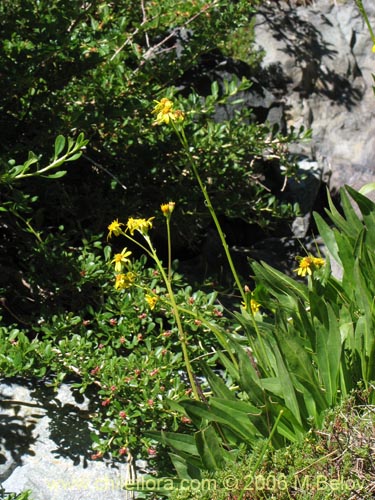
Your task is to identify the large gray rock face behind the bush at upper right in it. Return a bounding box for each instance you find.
[255,0,375,195]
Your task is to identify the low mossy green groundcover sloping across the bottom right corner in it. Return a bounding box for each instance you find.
[165,389,375,500]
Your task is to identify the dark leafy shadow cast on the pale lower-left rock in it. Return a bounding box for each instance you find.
[0,378,99,474]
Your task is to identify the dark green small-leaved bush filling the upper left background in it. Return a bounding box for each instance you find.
[0,0,306,328]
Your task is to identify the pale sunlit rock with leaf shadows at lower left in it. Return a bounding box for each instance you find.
[0,379,134,500]
